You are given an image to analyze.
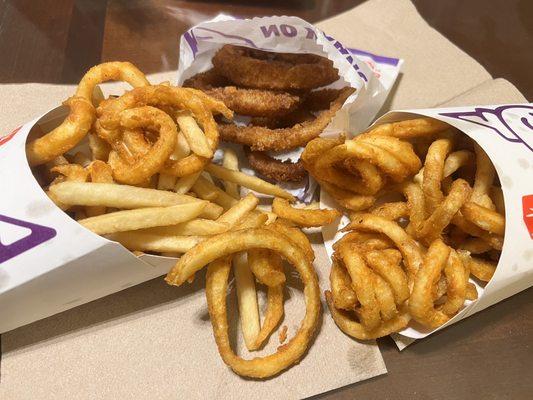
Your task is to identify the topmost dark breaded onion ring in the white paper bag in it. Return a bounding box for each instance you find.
[212,45,339,90]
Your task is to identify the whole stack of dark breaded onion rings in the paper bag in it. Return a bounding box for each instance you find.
[184,45,353,182]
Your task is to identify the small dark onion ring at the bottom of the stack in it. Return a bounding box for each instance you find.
[244,147,307,182]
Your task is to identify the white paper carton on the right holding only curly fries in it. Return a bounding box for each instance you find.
[321,104,533,339]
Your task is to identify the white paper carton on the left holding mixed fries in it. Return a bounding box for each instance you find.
[0,107,180,332]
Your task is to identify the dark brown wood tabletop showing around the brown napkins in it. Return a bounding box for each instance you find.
[0,0,533,400]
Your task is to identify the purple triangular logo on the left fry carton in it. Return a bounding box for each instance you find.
[0,214,57,264]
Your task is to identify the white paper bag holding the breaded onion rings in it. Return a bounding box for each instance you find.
[178,15,403,201]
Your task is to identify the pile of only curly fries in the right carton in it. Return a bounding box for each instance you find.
[302,118,505,340]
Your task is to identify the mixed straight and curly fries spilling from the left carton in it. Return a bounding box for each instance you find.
[27,62,340,378]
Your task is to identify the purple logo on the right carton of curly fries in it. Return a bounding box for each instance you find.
[440,104,533,152]
